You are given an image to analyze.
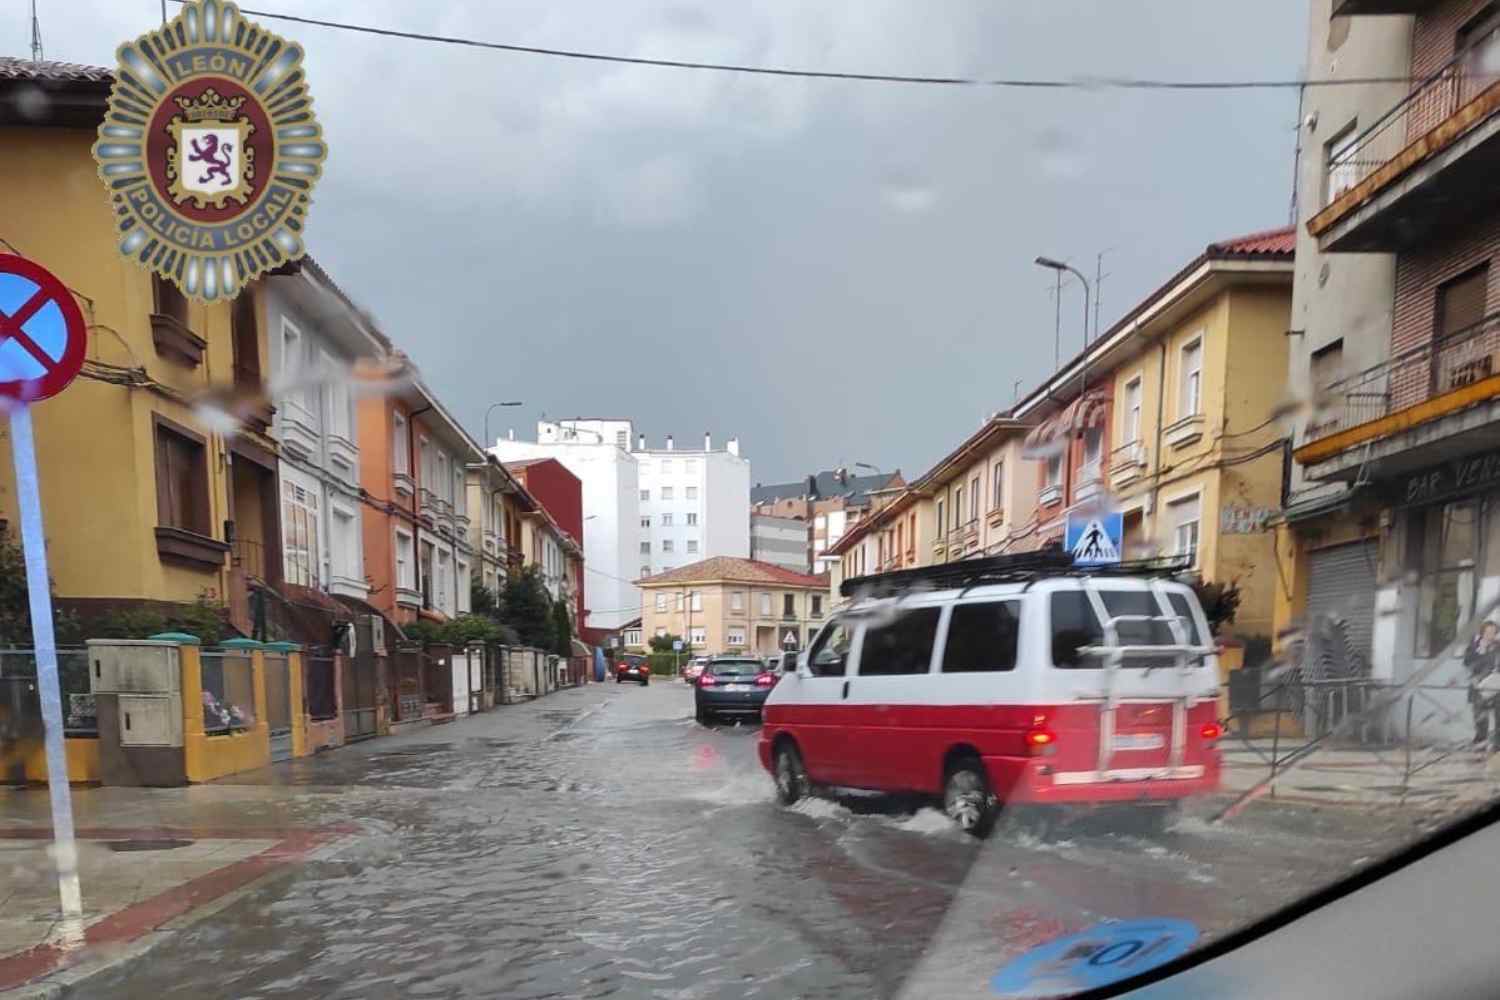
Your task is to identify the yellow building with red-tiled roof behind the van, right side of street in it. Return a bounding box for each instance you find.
[1014,228,1295,639]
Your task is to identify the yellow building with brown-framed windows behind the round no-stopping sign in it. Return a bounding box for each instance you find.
[0,58,279,625]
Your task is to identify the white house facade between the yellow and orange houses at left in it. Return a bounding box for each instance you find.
[266,270,381,600]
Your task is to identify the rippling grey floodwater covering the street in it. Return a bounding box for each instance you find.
[69,682,1428,999]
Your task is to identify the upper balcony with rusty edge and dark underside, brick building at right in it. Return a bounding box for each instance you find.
[1308,48,1500,253]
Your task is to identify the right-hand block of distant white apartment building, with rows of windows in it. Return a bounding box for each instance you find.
[636,433,750,576]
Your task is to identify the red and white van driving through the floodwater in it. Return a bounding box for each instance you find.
[759,573,1221,837]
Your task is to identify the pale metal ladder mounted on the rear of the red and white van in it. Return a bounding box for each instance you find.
[1079,577,1215,775]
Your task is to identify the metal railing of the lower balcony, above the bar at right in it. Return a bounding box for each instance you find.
[1304,313,1500,442]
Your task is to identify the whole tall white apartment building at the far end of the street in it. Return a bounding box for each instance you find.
[491,417,750,628]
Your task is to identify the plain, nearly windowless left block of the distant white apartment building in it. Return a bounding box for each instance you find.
[491,420,642,628]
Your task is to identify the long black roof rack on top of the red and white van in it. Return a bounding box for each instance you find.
[839,547,1191,597]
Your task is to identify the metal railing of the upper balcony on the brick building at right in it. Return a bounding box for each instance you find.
[1328,48,1500,202]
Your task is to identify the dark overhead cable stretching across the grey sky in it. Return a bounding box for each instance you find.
[173,0,1416,90]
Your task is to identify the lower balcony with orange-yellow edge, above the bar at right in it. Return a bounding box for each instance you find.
[1293,313,1500,480]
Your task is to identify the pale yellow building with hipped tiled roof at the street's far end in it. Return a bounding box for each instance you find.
[636,556,830,655]
